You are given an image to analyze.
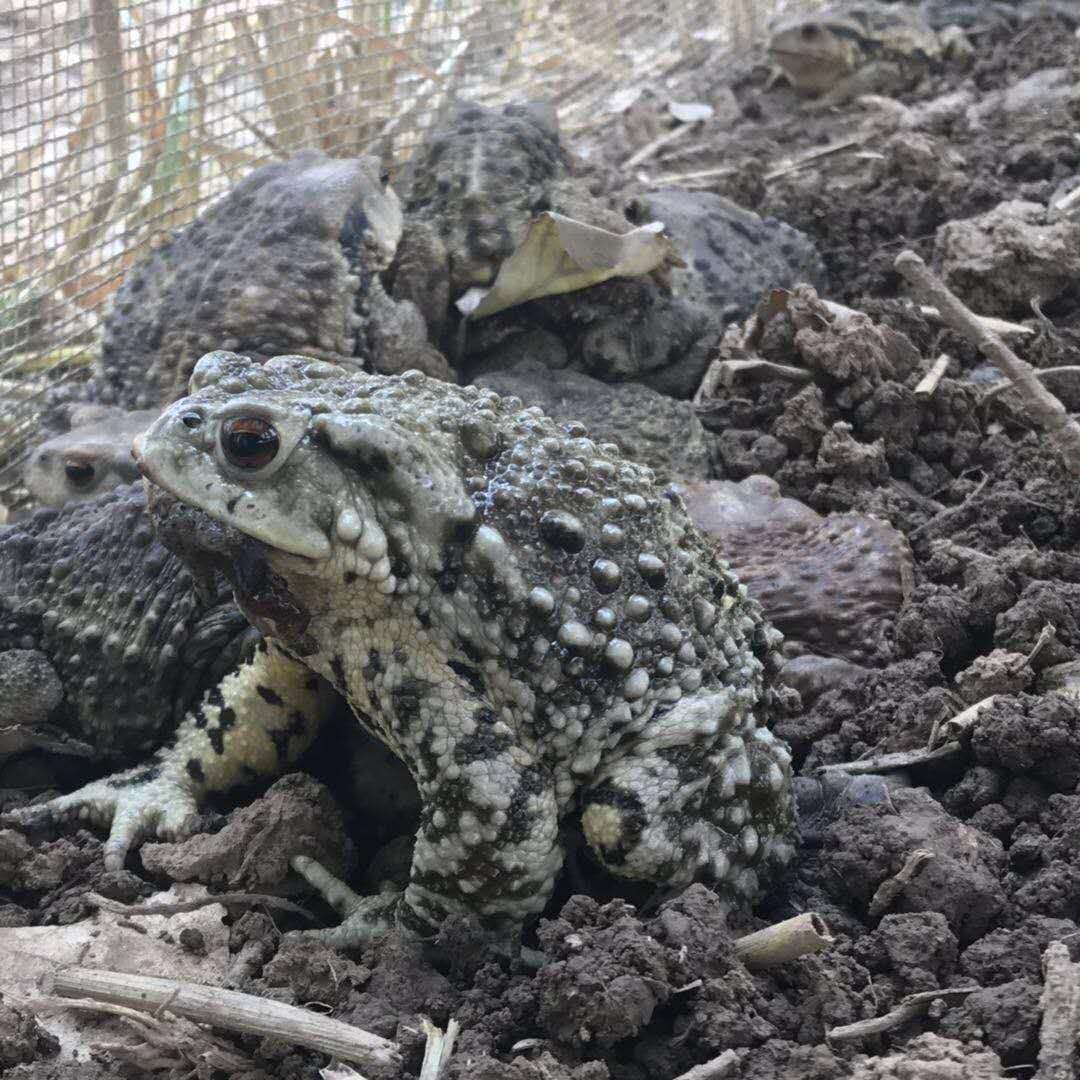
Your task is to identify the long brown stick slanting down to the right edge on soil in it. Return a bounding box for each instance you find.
[893,251,1080,476]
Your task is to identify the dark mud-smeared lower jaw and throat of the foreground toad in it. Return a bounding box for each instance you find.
[145,478,311,643]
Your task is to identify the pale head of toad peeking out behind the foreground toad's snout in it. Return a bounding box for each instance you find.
[23,409,158,507]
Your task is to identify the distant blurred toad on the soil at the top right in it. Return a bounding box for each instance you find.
[769,0,943,105]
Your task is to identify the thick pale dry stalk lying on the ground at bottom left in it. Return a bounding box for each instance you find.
[52,968,402,1068]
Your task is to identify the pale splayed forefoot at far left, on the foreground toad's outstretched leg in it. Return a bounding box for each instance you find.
[0,766,198,869]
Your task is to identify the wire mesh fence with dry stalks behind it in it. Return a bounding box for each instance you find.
[0,0,813,490]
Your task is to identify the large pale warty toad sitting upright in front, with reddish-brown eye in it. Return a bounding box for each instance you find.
[136,353,793,933]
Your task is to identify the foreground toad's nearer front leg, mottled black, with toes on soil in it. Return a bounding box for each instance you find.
[294,670,563,946]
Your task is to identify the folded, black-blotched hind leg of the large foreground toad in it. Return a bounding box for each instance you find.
[581,693,794,901]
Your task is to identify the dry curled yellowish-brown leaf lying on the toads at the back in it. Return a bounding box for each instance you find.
[458,211,686,319]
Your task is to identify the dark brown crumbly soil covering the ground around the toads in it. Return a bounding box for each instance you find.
[0,8,1080,1080]
